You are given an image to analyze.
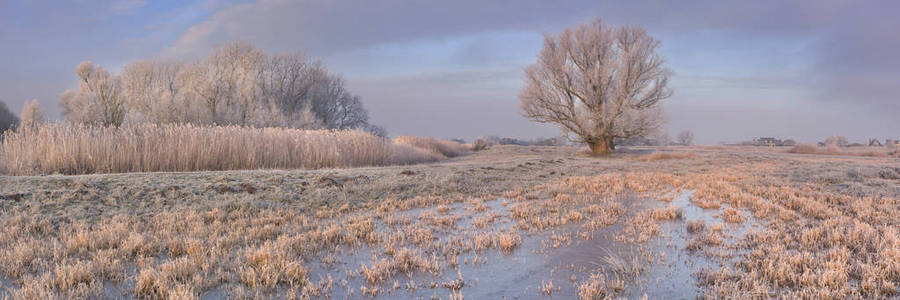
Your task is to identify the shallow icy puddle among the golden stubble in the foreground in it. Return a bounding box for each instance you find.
[294,191,758,299]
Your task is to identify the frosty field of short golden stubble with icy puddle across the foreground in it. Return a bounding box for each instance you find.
[0,145,900,299]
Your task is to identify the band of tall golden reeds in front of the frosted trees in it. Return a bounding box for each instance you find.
[0,124,464,175]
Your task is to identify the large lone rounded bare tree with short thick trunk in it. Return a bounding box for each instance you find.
[519,19,672,155]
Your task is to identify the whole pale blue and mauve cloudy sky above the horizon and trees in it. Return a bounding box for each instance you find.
[0,0,900,143]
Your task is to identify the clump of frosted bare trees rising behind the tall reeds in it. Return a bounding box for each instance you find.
[60,42,385,135]
